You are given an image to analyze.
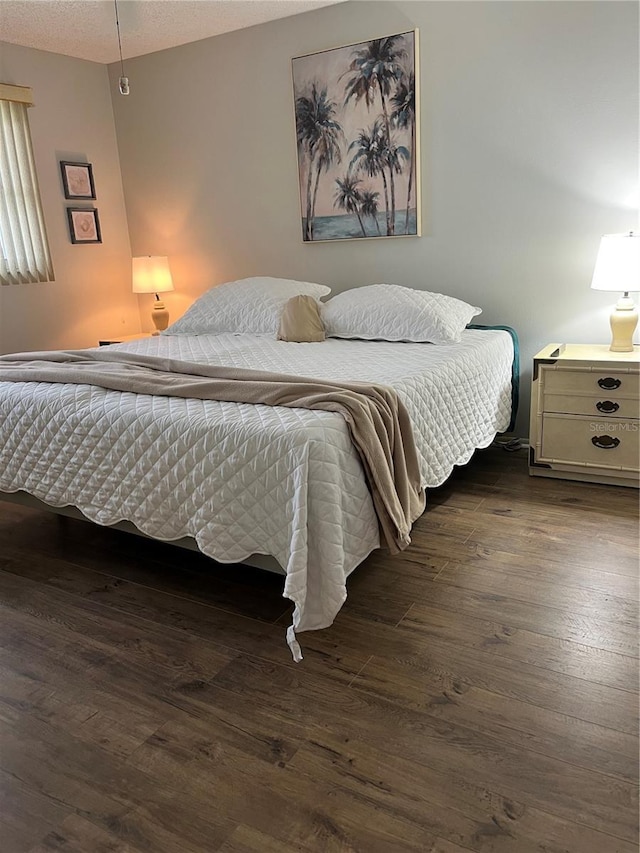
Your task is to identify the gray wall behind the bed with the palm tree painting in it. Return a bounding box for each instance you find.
[110,2,638,434]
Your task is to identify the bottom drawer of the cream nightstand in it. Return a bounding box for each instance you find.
[538,413,640,471]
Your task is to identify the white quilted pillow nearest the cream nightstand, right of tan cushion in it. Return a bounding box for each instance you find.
[322,284,482,344]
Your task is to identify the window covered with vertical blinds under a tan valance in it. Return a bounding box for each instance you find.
[0,83,54,284]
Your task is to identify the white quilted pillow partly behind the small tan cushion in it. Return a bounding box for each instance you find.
[165,276,331,337]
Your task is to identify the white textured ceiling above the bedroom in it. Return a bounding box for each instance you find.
[0,0,344,63]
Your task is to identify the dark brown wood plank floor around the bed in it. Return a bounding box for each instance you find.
[0,450,638,853]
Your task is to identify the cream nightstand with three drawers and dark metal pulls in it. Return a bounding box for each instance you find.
[529,344,640,488]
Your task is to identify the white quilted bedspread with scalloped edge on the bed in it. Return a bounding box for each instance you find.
[0,330,513,656]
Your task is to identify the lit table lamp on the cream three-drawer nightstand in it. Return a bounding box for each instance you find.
[591,231,640,352]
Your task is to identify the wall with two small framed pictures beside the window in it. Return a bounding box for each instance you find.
[0,43,140,352]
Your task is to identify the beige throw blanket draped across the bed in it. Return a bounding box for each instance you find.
[0,348,425,553]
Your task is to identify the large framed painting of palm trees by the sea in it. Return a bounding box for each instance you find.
[292,30,420,243]
